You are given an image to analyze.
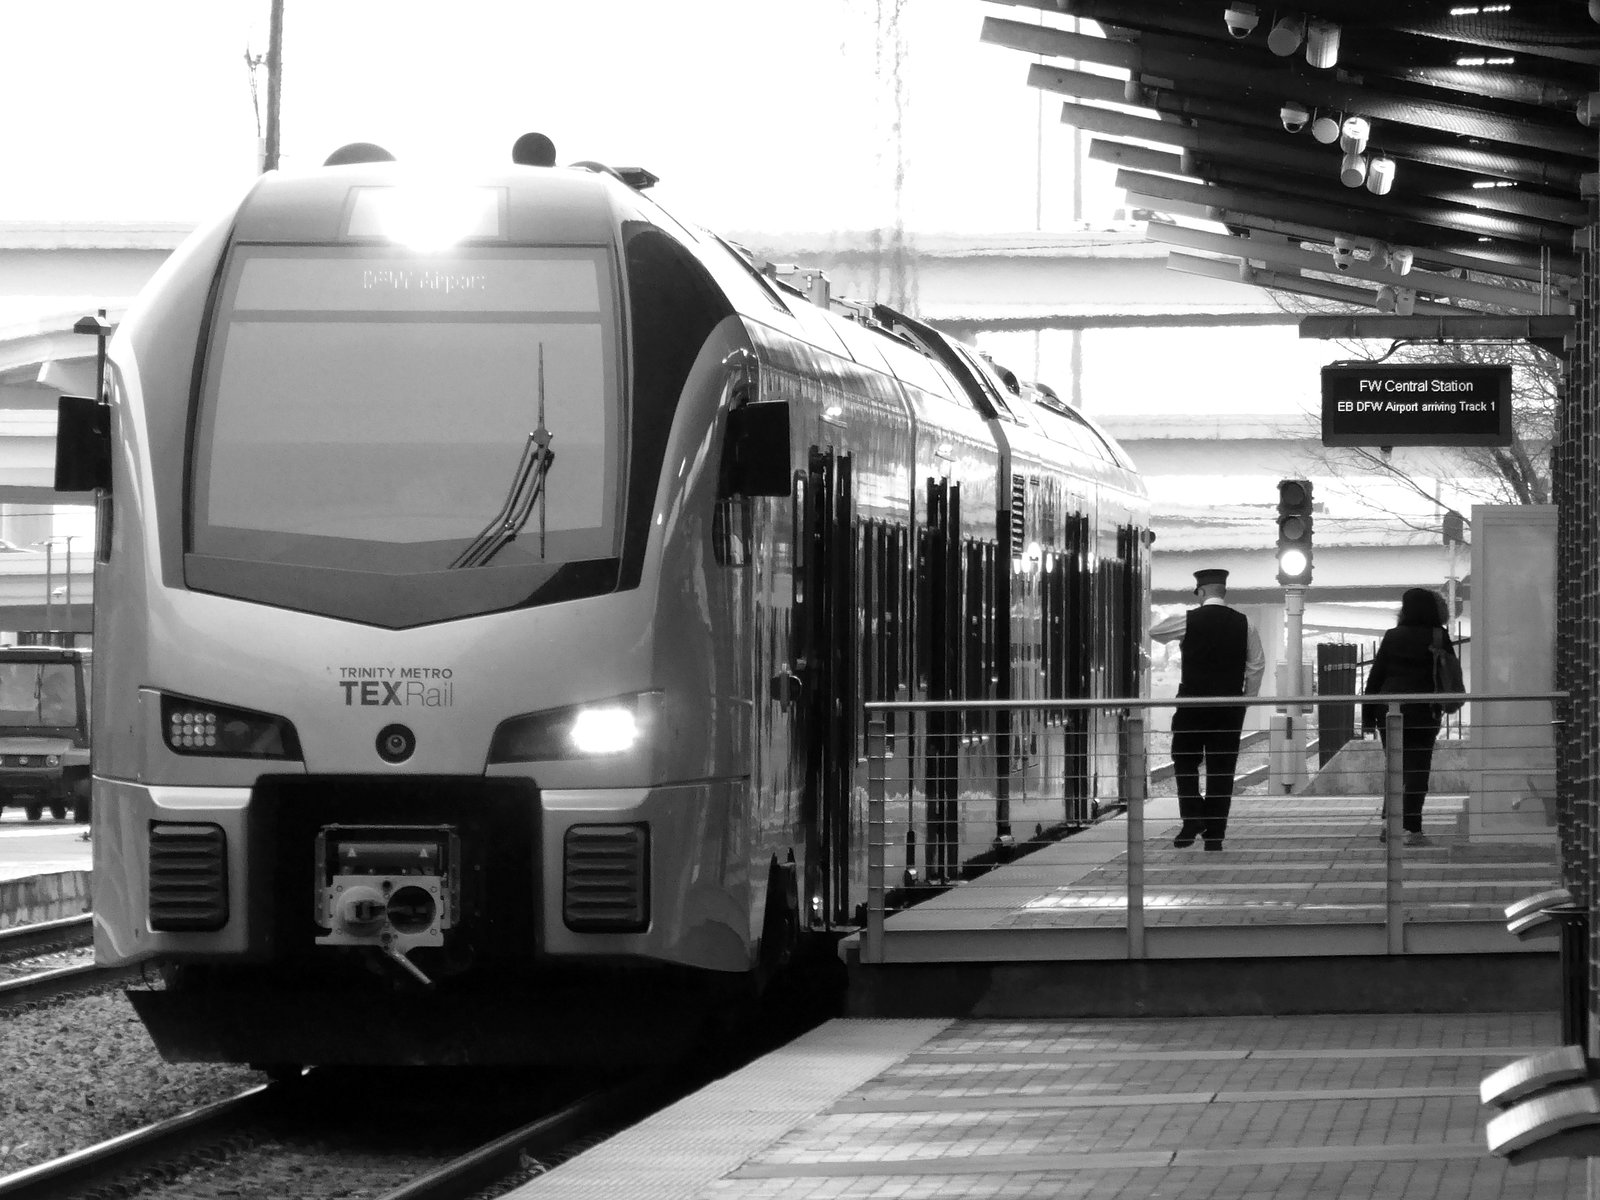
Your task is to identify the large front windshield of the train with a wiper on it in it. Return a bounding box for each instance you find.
[190,246,621,608]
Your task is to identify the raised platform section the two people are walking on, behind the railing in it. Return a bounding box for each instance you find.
[843,795,1560,1018]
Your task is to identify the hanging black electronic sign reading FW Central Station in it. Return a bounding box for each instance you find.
[1322,363,1510,446]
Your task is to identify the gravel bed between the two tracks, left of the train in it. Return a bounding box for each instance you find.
[0,990,266,1174]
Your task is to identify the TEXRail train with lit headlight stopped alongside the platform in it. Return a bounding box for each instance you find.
[58,139,1150,1067]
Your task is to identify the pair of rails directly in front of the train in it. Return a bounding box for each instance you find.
[0,1072,683,1200]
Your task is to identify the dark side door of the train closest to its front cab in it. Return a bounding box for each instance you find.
[794,446,861,926]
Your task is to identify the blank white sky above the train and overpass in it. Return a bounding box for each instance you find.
[0,0,1120,232]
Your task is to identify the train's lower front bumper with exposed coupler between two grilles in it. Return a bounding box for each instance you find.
[94,776,752,982]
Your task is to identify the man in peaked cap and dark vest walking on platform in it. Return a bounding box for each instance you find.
[1173,570,1267,850]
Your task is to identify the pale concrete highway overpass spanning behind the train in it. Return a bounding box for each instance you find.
[0,221,1484,630]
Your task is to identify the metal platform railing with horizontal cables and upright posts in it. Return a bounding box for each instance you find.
[861,693,1565,962]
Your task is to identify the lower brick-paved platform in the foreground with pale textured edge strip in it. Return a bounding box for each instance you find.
[507,1013,1586,1200]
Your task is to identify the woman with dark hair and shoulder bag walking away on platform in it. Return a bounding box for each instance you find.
[1362,587,1461,846]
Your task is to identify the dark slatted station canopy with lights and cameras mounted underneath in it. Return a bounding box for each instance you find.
[982,0,1600,350]
